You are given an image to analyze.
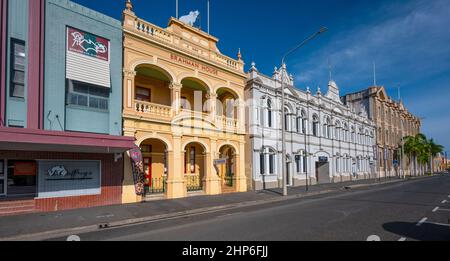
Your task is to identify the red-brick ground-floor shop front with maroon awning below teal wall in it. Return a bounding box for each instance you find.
[0,128,134,216]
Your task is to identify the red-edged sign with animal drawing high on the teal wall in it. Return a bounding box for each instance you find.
[67,27,109,61]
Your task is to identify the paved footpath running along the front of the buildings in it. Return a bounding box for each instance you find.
[0,173,440,241]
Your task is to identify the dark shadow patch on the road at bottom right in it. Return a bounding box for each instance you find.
[383,222,450,241]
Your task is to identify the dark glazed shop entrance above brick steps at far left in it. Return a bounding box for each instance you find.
[6,160,37,197]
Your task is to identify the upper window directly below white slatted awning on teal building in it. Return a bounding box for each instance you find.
[67,80,110,110]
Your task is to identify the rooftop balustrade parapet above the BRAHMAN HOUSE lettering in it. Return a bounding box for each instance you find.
[133,18,244,72]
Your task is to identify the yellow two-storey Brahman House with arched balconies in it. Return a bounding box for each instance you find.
[123,2,247,203]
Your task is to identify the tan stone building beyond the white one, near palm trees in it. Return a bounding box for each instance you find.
[344,87,421,177]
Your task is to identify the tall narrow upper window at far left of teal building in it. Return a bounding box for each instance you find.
[9,40,26,98]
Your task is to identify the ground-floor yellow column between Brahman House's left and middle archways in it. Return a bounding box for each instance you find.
[166,136,187,199]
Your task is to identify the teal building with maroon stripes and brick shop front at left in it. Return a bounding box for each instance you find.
[0,0,134,214]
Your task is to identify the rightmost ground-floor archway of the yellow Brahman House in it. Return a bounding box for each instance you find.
[219,145,236,193]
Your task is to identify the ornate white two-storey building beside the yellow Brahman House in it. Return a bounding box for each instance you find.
[245,64,376,190]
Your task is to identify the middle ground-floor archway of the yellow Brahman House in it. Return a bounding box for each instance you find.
[183,142,206,192]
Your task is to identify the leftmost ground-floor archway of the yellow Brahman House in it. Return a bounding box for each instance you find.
[140,139,169,195]
